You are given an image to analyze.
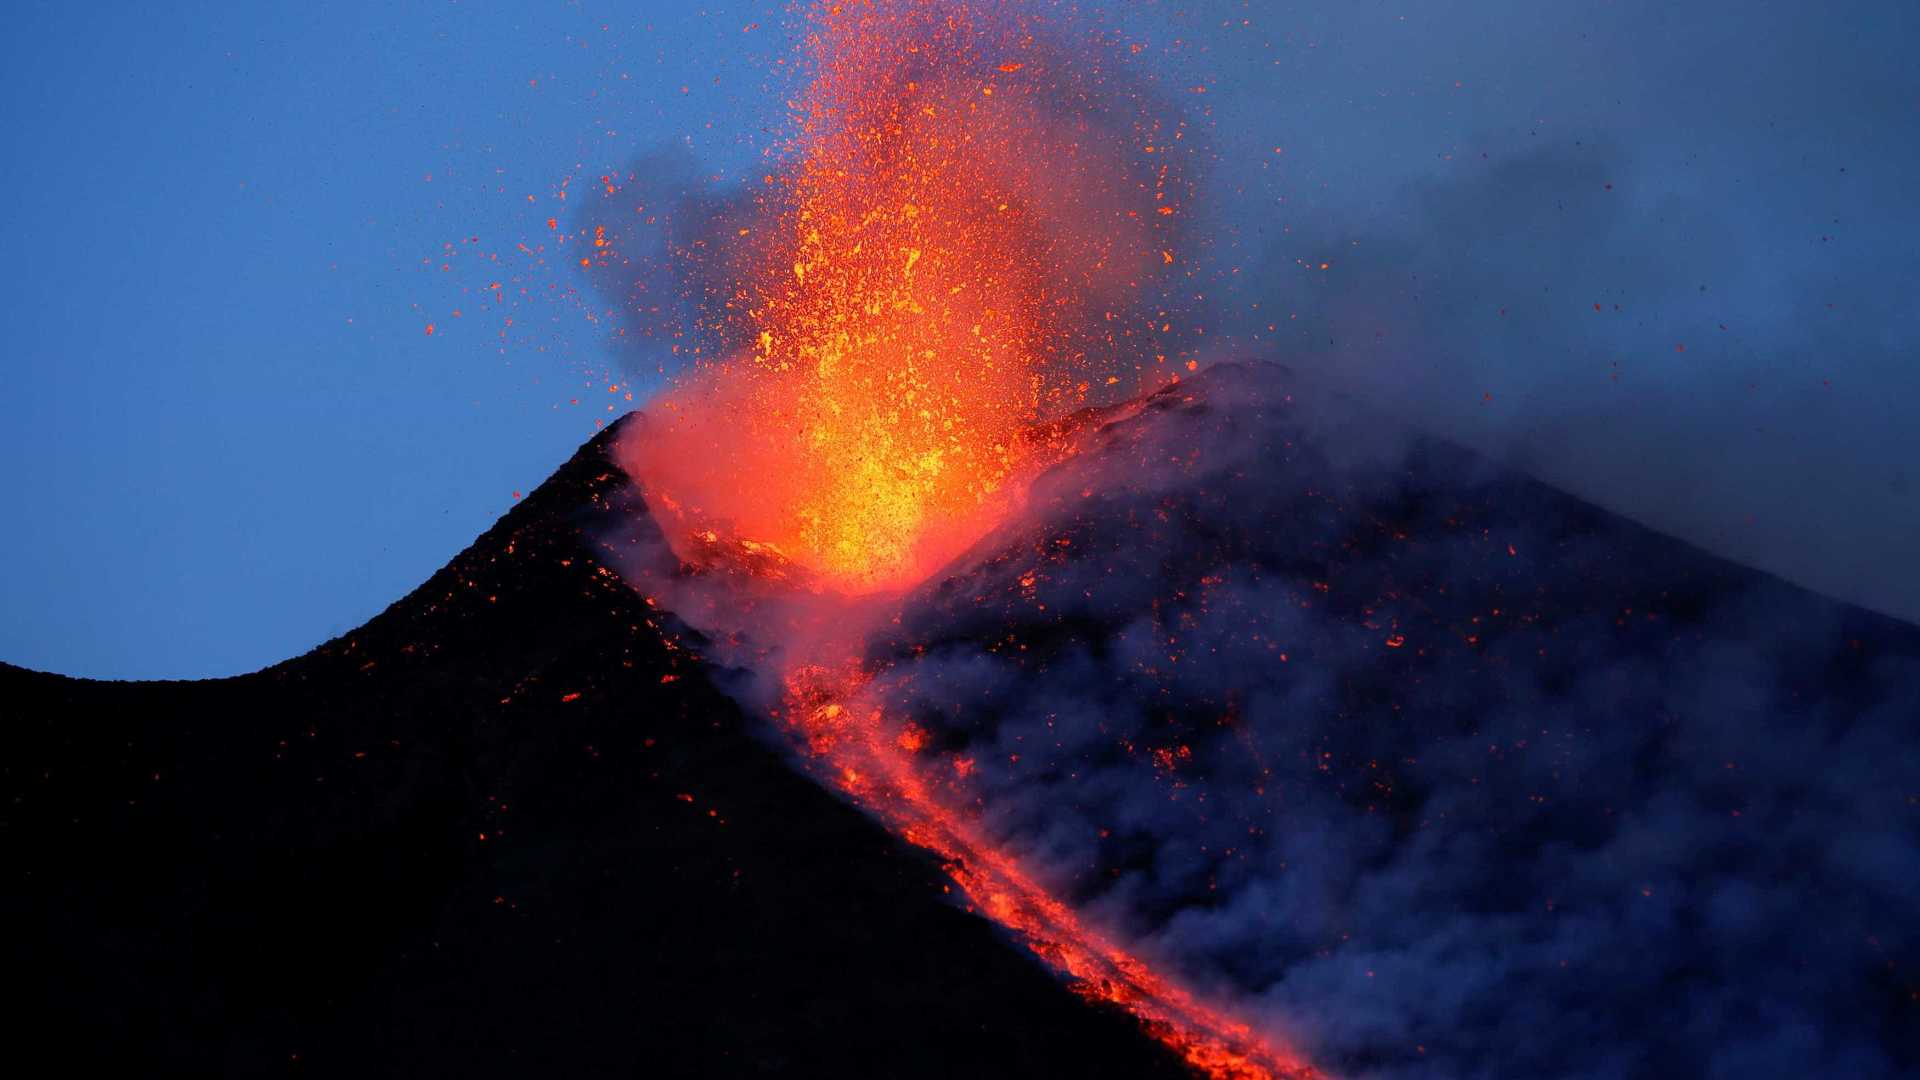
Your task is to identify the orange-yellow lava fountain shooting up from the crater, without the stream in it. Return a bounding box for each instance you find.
[630,2,1179,592]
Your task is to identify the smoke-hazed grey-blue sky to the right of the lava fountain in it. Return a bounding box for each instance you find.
[1179,0,1920,621]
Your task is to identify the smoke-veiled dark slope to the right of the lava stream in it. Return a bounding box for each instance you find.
[610,365,1920,1076]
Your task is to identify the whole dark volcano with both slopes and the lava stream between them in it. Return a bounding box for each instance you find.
[0,365,1920,1076]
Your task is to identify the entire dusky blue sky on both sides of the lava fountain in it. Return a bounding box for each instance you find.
[0,0,1920,676]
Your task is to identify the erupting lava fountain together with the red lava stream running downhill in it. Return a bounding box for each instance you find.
[620,0,1309,1078]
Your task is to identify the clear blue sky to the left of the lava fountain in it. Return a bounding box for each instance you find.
[0,0,781,676]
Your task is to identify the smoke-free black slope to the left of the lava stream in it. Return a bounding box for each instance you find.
[0,417,1181,1076]
